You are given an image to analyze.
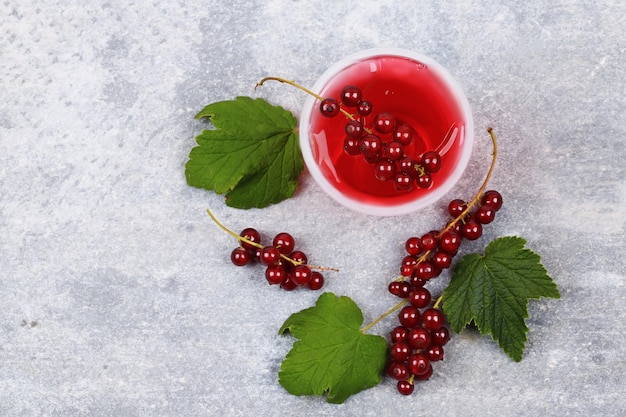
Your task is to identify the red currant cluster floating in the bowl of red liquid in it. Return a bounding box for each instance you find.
[320,85,441,192]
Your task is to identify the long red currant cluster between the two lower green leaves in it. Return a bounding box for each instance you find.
[387,190,502,395]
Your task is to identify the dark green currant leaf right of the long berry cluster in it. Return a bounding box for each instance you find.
[443,236,561,362]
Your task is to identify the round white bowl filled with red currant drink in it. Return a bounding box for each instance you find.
[300,49,473,215]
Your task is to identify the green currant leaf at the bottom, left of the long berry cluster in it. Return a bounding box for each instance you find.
[278,293,387,404]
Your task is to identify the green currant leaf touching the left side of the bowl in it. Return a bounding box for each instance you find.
[185,97,304,208]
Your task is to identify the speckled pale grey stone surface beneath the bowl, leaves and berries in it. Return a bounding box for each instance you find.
[0,0,626,416]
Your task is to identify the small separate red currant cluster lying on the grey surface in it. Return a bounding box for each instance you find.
[230,227,324,291]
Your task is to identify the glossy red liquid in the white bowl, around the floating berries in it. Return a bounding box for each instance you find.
[309,56,466,206]
